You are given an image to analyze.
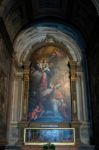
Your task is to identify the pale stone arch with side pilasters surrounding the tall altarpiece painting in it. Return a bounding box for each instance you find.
[9,23,92,144]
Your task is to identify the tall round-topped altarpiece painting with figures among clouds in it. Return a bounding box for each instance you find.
[28,46,71,122]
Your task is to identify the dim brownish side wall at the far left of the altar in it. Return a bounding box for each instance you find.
[0,33,11,144]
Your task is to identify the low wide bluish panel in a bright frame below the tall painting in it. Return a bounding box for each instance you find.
[24,128,75,145]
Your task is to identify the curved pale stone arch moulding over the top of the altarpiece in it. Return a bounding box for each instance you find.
[14,25,85,65]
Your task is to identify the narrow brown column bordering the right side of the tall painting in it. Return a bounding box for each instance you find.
[69,61,80,145]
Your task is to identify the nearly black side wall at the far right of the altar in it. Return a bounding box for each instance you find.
[87,19,99,150]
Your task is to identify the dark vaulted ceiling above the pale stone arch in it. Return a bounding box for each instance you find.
[0,0,98,42]
